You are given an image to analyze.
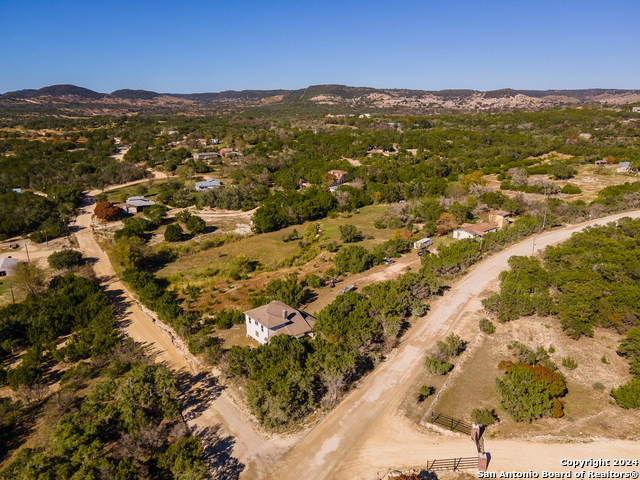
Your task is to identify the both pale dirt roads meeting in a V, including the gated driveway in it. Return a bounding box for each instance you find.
[76,192,640,480]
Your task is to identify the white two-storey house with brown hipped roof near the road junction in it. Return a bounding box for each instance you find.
[244,300,316,345]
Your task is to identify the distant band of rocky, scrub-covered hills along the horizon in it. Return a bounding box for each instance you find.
[0,85,640,115]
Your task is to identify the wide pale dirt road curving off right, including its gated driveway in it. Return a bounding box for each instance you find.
[242,211,640,480]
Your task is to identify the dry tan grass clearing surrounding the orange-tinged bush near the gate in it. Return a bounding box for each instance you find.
[435,317,640,438]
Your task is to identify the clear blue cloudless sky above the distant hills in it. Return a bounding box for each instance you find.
[0,0,640,93]
